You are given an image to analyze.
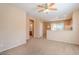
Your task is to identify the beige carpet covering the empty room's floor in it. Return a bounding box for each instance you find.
[0,39,79,55]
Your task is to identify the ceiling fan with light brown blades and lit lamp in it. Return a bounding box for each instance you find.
[37,3,57,12]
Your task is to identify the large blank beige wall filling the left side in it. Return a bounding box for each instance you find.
[0,4,28,52]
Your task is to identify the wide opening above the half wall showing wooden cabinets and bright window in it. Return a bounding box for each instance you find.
[45,19,73,31]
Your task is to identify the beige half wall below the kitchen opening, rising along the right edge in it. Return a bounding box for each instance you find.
[47,10,79,44]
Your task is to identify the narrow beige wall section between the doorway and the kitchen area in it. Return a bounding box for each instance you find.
[34,19,43,38]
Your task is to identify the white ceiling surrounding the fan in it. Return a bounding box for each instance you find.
[8,3,79,21]
